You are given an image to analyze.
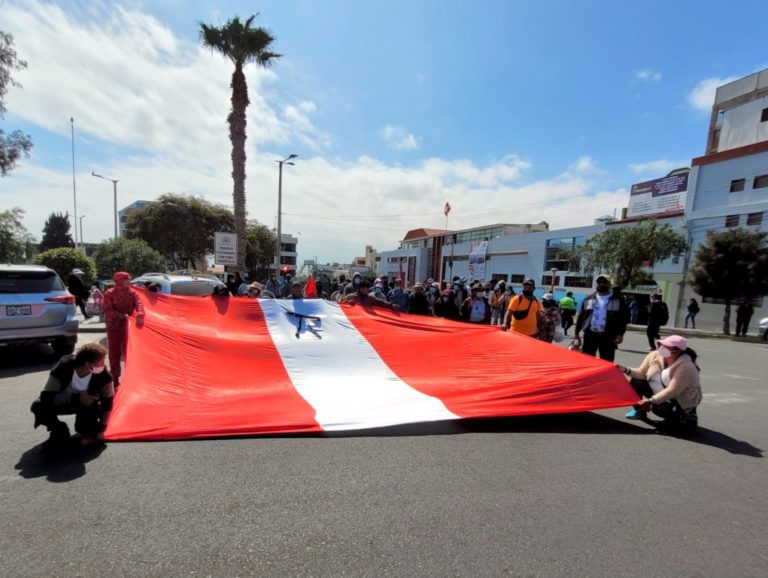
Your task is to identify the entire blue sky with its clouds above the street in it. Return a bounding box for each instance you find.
[0,0,768,261]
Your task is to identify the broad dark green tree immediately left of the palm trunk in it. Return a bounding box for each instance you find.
[125,194,233,269]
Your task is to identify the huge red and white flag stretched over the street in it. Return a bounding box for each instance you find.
[106,292,637,440]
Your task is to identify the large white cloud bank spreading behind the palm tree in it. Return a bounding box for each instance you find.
[0,0,628,261]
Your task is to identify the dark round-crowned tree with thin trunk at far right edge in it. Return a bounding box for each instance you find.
[688,227,768,335]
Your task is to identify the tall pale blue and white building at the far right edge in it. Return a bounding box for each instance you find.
[677,69,768,332]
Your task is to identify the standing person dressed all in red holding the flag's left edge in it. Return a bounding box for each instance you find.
[104,271,144,386]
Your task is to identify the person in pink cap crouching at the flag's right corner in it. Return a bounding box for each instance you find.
[617,335,702,435]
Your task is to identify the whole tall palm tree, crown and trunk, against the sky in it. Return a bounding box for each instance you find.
[199,14,282,268]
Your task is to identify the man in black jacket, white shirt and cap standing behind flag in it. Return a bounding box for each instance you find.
[573,273,629,361]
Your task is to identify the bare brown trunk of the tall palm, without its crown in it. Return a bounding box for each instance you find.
[227,63,249,269]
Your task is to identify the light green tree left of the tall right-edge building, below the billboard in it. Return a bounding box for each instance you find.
[578,220,688,287]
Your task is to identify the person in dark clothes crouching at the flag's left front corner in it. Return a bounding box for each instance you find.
[30,343,115,451]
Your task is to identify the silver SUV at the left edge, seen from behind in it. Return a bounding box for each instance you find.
[0,265,79,355]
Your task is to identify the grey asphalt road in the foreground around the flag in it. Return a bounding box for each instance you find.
[0,320,768,576]
